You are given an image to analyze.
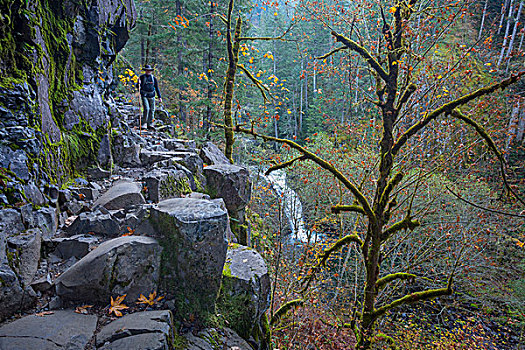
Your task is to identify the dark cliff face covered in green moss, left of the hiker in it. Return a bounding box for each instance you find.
[0,0,136,204]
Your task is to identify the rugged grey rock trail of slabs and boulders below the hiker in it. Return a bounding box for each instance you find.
[0,105,270,350]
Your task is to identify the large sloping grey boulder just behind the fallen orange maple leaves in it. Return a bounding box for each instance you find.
[55,236,162,304]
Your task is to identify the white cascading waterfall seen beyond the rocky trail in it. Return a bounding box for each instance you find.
[265,170,316,243]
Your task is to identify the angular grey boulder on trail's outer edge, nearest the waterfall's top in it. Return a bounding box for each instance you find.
[204,164,252,218]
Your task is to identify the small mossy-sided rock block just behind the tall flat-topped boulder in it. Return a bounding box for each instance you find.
[142,169,191,203]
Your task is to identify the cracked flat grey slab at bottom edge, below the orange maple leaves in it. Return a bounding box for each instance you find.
[96,310,174,350]
